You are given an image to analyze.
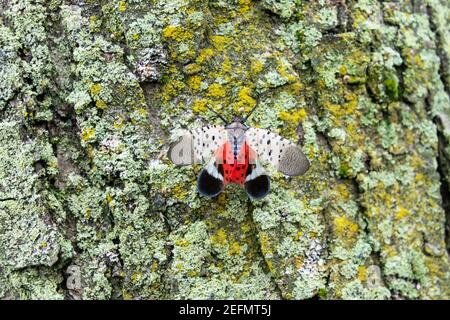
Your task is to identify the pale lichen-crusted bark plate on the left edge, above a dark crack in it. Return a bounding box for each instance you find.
[0,122,59,269]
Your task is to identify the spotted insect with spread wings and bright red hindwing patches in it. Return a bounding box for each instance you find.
[168,106,309,200]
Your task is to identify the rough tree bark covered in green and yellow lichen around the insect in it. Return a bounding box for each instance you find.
[0,0,450,299]
